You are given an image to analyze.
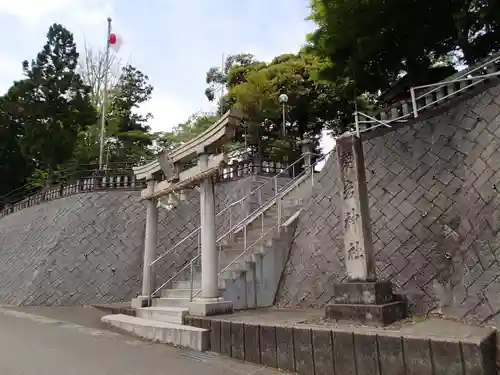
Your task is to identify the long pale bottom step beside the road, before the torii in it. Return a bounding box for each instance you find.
[101,314,210,351]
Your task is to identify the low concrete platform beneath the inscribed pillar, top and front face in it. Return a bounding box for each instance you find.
[185,309,497,375]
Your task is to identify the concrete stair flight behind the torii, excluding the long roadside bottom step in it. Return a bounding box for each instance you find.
[153,176,312,310]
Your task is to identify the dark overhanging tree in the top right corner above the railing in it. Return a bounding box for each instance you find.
[309,0,500,92]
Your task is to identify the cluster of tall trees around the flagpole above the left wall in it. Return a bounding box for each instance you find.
[0,24,156,206]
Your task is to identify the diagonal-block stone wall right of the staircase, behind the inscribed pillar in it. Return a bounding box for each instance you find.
[277,81,500,325]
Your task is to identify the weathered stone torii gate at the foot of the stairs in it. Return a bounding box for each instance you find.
[132,110,242,316]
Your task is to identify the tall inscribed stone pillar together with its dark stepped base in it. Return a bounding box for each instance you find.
[325,133,406,325]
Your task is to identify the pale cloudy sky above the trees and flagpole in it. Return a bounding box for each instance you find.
[0,0,336,153]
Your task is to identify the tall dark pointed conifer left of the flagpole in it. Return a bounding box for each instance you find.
[14,24,96,185]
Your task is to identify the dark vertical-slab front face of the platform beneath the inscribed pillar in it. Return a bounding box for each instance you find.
[185,317,496,375]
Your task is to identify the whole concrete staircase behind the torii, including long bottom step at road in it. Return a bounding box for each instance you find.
[102,172,311,351]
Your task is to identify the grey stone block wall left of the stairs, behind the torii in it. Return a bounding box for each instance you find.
[0,176,286,305]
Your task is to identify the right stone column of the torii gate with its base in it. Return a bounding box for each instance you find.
[189,153,233,316]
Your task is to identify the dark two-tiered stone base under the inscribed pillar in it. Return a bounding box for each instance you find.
[325,281,407,325]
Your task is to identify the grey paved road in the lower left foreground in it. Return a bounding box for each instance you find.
[0,308,278,375]
